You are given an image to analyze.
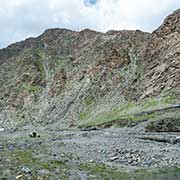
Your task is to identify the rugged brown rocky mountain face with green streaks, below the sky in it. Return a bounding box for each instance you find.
[0,10,180,128]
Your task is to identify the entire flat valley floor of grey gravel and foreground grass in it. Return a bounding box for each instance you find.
[0,126,180,180]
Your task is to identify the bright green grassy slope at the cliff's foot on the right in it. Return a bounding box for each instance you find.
[79,95,177,127]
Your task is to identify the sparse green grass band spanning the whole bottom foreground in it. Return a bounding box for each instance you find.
[0,149,180,180]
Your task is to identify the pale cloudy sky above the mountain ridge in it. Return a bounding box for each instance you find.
[0,0,180,48]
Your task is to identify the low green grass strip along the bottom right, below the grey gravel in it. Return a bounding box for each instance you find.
[80,163,180,180]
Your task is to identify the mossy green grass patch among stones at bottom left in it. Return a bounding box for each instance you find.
[0,149,69,180]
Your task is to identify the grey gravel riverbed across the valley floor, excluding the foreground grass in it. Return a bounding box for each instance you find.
[0,128,180,179]
